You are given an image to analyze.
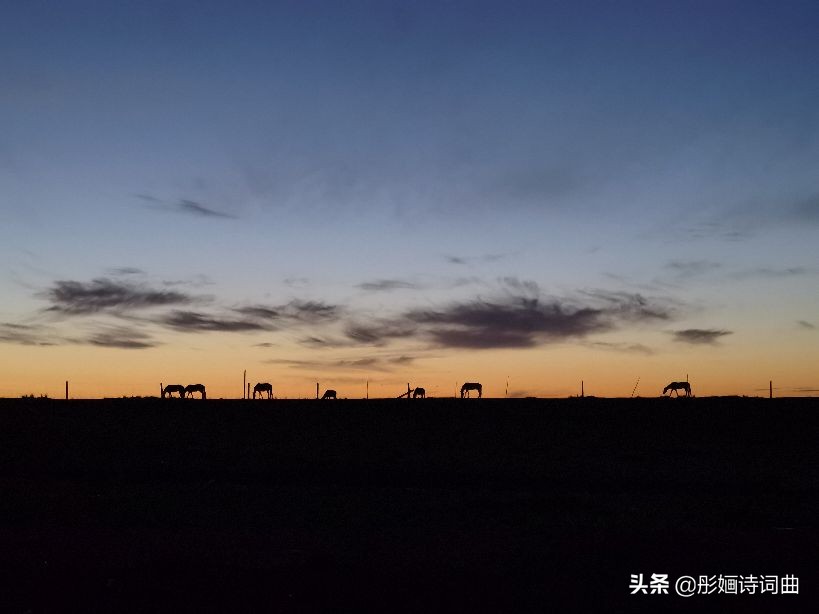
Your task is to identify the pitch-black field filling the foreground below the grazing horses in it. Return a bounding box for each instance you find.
[0,399,819,612]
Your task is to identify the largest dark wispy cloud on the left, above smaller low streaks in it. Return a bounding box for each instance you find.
[45,278,193,315]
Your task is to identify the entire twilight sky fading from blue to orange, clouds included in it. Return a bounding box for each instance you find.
[0,0,819,398]
